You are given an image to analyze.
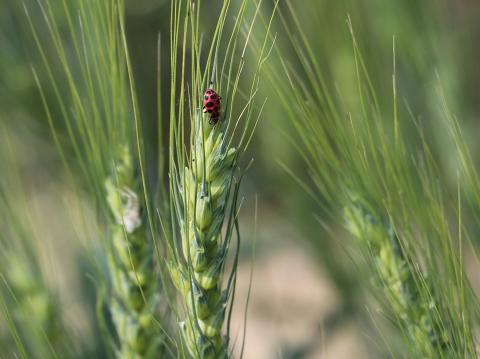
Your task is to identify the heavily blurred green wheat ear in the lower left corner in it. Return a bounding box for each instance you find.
[0,125,76,358]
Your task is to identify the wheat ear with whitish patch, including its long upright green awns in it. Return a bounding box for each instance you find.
[26,0,170,359]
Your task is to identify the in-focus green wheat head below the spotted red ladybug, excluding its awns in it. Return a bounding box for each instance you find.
[169,112,236,358]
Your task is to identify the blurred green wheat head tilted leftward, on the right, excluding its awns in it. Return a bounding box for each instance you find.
[344,196,449,358]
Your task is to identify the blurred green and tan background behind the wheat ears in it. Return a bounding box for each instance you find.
[0,0,480,358]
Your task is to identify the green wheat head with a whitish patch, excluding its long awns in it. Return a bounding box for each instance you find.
[105,147,162,358]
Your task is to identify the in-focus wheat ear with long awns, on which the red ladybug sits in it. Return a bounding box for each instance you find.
[167,1,269,359]
